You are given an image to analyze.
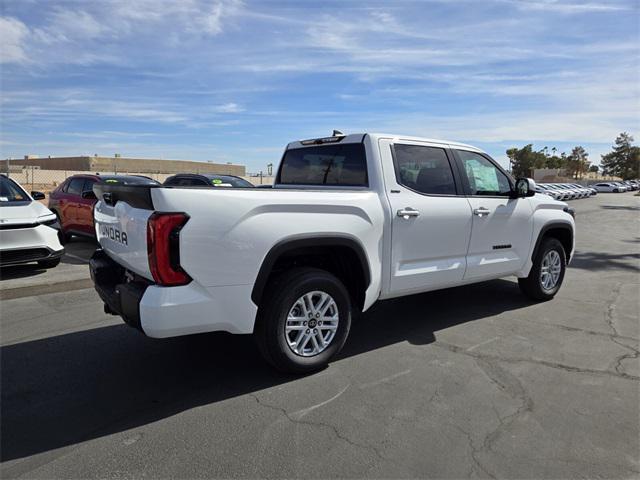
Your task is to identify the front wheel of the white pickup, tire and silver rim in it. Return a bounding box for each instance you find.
[518,238,567,301]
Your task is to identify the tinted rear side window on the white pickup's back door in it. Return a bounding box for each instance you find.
[393,144,456,195]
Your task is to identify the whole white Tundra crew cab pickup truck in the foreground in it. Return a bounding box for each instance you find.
[91,134,575,372]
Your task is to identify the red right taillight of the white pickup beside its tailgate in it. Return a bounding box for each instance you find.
[147,212,191,286]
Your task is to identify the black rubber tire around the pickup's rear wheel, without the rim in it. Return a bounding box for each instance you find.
[254,268,351,374]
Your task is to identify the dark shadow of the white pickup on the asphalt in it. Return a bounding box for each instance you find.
[0,280,530,464]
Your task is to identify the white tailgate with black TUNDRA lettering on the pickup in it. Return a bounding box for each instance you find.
[94,185,153,280]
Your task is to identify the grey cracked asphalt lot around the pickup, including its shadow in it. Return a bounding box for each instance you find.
[0,193,640,478]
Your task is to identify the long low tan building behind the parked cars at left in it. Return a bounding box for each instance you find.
[10,155,246,177]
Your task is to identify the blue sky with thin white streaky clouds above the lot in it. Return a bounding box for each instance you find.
[0,0,640,172]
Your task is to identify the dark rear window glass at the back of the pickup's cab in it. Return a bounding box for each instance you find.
[277,143,369,187]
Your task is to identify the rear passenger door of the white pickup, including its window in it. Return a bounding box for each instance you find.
[380,140,472,296]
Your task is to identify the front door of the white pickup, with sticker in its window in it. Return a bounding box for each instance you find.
[453,149,533,280]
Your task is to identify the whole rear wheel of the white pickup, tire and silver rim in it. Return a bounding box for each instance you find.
[254,268,351,373]
